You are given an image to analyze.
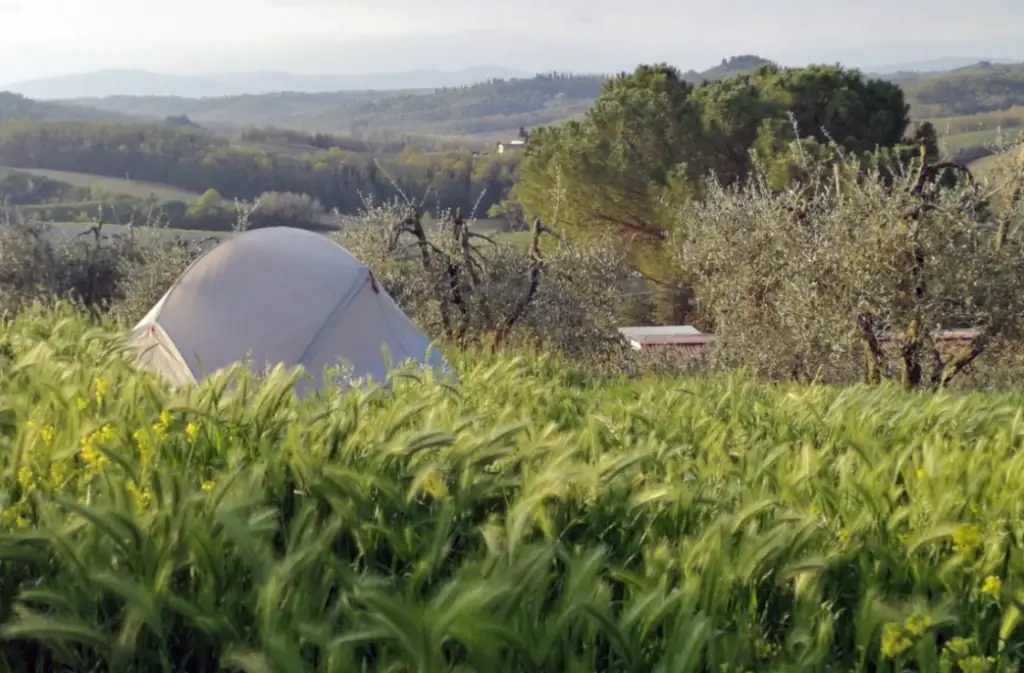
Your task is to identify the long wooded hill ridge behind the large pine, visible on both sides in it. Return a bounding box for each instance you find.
[8,55,1024,138]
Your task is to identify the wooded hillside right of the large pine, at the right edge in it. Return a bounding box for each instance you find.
[900,62,1024,119]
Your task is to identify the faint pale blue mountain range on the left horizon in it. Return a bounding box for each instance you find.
[6,67,531,100]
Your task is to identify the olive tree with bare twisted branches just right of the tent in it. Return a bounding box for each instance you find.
[338,205,629,356]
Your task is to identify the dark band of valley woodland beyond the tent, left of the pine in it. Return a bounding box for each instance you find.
[0,121,516,214]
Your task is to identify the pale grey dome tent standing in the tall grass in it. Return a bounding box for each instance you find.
[129,226,446,395]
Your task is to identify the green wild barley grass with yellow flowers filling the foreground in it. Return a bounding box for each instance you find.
[0,310,1024,673]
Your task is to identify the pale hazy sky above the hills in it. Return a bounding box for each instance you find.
[0,0,1024,83]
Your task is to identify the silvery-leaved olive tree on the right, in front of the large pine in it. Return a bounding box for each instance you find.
[674,138,1024,387]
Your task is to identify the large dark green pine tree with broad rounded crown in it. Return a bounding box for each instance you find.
[514,65,908,320]
